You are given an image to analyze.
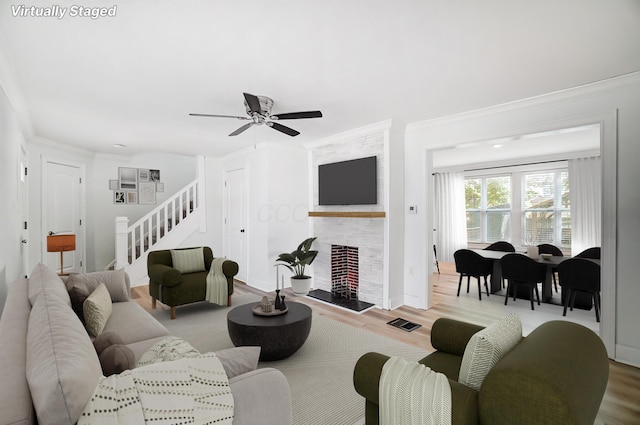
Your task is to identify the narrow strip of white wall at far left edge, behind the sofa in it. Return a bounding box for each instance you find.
[0,86,26,313]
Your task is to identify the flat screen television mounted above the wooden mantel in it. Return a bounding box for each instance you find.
[318,156,378,205]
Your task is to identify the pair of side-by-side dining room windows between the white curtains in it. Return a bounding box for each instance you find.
[465,168,571,248]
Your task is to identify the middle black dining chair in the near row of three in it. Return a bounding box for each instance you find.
[500,253,546,310]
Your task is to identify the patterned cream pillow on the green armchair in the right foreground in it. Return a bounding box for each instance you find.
[458,313,522,390]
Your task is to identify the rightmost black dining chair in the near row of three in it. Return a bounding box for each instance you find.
[558,257,600,322]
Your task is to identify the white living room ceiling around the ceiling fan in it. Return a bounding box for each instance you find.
[0,0,640,156]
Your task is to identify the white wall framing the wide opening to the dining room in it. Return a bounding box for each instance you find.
[405,73,640,365]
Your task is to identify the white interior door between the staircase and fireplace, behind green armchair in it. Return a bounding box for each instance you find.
[224,169,247,282]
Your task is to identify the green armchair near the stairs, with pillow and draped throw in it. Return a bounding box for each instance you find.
[147,246,238,319]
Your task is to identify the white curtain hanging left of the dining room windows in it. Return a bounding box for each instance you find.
[435,172,467,263]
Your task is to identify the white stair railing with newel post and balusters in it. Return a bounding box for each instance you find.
[115,180,200,269]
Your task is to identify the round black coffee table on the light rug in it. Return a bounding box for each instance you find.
[227,301,311,361]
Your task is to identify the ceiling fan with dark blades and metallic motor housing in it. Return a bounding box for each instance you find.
[189,93,322,137]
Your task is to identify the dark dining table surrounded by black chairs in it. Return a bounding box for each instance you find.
[471,249,600,309]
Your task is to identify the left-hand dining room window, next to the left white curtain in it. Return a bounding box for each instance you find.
[465,176,511,242]
